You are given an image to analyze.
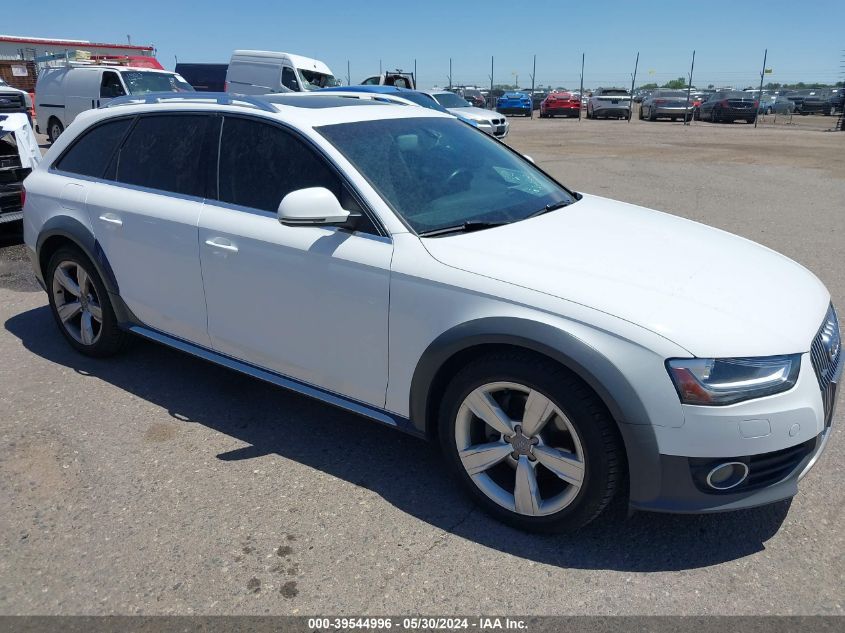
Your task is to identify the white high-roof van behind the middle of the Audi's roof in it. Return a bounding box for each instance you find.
[226,51,340,95]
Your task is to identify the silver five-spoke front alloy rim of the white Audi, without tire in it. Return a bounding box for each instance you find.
[455,382,586,516]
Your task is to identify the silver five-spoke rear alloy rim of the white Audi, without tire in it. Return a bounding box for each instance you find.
[52,261,103,345]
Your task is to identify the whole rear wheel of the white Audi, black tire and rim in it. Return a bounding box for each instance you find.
[45,246,128,357]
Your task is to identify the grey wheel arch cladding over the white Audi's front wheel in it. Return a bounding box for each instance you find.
[409,317,660,501]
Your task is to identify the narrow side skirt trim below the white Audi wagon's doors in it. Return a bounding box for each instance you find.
[128,325,421,437]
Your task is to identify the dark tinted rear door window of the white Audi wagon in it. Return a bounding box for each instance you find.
[114,114,210,196]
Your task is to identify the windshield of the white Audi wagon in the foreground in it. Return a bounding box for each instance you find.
[317,118,575,233]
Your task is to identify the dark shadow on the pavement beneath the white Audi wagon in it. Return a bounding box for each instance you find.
[5,306,789,572]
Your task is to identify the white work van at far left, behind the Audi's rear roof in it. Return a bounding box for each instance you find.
[35,64,193,142]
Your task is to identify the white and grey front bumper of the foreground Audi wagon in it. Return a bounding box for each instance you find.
[620,353,845,513]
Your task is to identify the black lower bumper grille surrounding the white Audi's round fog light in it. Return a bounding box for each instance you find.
[689,437,819,495]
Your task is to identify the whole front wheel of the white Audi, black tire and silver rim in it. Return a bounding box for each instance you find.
[439,352,625,532]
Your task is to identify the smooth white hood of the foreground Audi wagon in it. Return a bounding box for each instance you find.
[423,194,830,357]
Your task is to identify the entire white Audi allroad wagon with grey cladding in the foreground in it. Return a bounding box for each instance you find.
[19,94,843,531]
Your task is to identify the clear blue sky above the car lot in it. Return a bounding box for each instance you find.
[13,0,845,88]
